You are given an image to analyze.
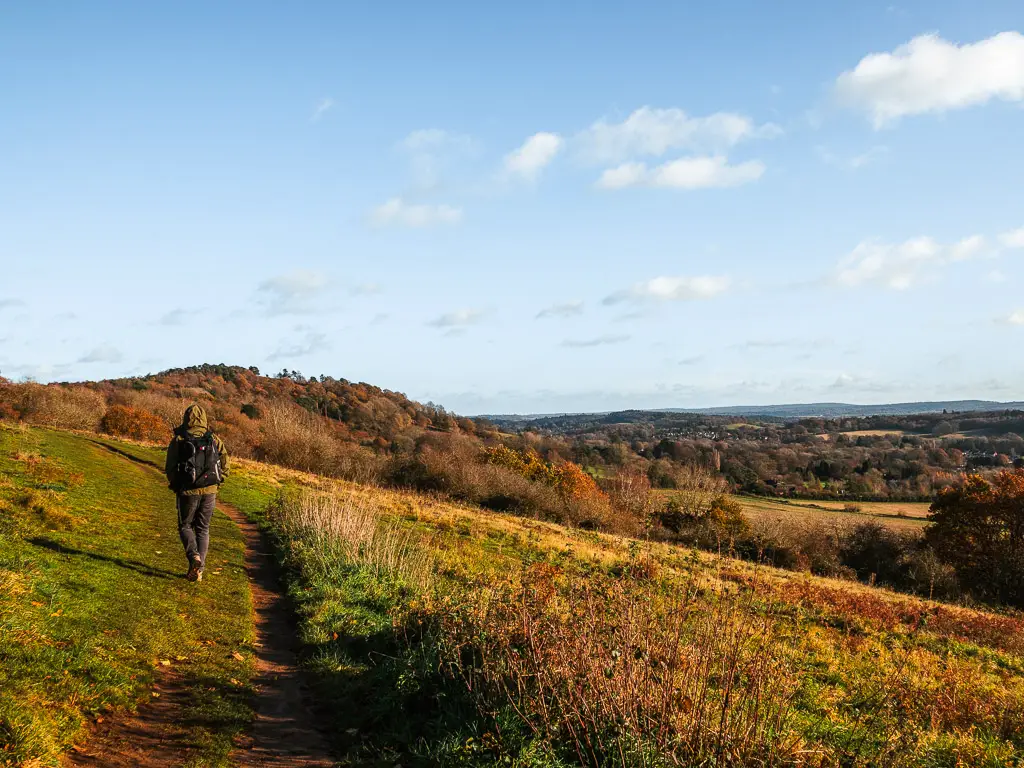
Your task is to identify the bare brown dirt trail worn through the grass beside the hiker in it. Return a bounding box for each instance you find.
[65,441,336,768]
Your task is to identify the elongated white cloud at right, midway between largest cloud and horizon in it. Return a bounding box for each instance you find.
[834,234,986,291]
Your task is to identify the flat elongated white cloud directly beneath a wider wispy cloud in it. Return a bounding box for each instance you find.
[597,155,765,189]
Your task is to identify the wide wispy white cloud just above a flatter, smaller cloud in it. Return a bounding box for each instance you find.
[575,106,781,163]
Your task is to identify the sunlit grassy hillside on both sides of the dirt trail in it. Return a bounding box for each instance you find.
[8,429,1024,768]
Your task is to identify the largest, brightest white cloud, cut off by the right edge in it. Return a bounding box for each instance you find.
[836,32,1024,128]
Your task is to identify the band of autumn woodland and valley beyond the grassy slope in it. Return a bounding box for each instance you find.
[0,366,1024,605]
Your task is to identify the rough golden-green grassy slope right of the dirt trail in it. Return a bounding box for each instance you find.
[96,438,1024,768]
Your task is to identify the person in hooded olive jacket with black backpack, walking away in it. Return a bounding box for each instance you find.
[164,403,227,582]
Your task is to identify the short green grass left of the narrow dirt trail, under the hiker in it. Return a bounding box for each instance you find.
[0,427,254,766]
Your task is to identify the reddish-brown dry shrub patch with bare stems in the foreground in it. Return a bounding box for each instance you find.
[437,563,797,766]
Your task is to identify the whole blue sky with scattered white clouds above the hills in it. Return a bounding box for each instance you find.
[0,2,1024,414]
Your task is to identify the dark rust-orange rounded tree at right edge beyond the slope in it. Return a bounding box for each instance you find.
[925,470,1024,607]
